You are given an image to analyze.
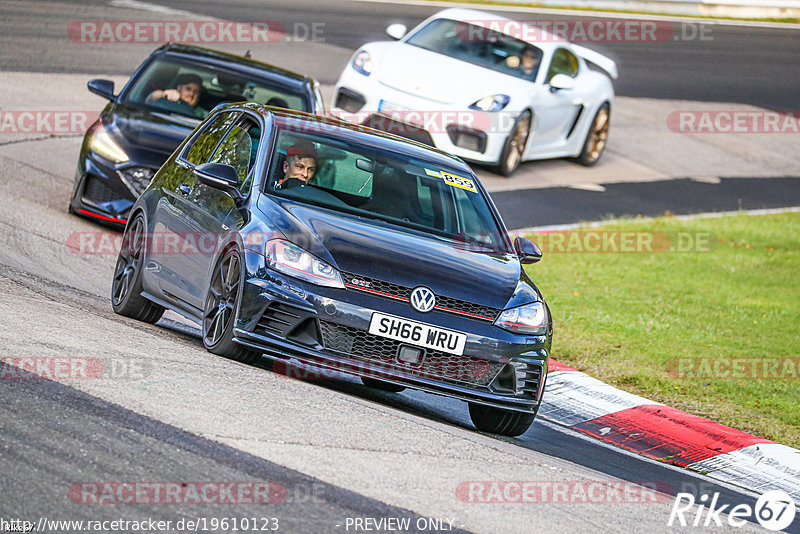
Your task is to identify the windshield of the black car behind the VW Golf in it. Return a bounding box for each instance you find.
[125,57,310,119]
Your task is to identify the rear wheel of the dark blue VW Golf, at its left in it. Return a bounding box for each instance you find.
[111,213,164,324]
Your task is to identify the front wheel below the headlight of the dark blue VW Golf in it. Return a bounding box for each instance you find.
[202,248,261,363]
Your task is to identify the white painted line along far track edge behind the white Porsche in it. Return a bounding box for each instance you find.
[354,0,800,30]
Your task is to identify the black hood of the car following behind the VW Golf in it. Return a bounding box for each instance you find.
[103,105,199,160]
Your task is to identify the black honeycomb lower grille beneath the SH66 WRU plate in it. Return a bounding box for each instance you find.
[320,321,504,386]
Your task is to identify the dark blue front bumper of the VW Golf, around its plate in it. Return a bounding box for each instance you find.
[234,253,550,413]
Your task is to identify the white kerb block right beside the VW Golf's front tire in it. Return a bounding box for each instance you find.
[539,371,661,426]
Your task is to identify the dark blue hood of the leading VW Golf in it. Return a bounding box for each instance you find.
[264,197,524,309]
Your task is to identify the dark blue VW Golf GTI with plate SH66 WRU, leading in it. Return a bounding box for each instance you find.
[112,103,553,436]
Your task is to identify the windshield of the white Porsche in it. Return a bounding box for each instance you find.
[406,19,542,81]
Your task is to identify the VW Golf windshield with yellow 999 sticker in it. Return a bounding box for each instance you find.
[267,131,510,253]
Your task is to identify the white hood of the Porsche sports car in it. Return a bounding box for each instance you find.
[374,43,532,108]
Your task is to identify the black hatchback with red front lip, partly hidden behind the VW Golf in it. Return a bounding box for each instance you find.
[69,44,324,228]
